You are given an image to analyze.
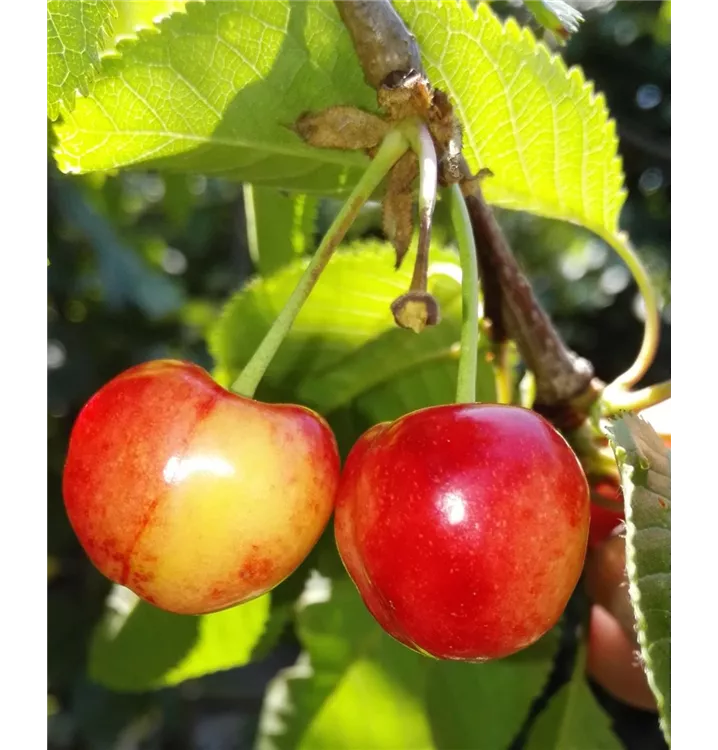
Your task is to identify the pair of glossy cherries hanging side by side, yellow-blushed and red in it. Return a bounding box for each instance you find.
[63,360,590,661]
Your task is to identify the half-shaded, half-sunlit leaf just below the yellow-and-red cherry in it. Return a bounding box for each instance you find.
[88,586,270,692]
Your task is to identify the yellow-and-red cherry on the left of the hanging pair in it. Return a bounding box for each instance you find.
[63,360,340,615]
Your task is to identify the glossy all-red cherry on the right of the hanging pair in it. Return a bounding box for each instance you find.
[334,404,589,662]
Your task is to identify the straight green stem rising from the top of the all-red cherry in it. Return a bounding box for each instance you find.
[451,185,479,404]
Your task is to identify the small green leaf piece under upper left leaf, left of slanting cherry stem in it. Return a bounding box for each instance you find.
[244,184,319,276]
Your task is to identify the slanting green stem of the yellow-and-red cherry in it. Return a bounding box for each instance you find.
[231,130,409,398]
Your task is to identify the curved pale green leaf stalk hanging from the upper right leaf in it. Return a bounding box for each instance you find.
[601,232,661,394]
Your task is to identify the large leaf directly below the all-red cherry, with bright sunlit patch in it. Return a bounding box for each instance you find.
[257,574,558,750]
